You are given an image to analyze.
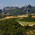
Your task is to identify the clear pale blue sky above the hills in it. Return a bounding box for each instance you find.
[0,0,35,9]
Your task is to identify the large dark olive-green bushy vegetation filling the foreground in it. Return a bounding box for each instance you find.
[0,18,35,35]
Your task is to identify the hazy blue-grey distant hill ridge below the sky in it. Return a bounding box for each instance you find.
[3,5,35,16]
